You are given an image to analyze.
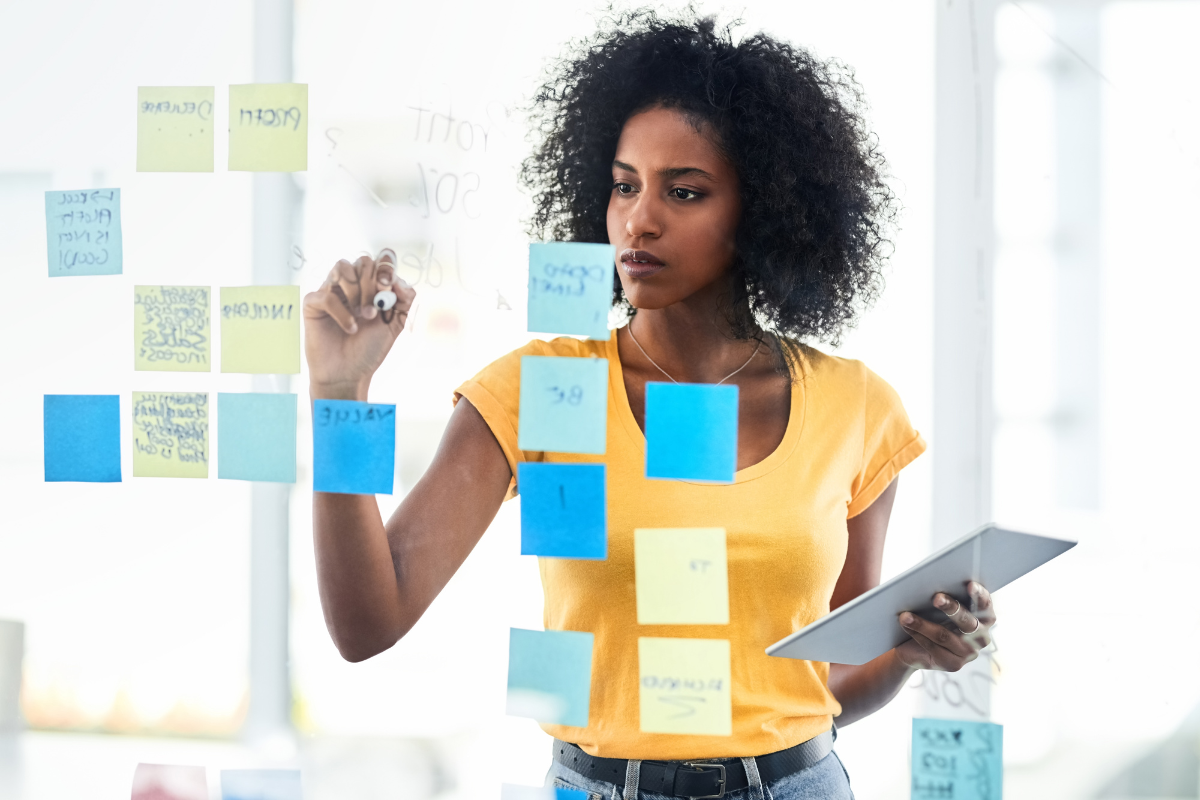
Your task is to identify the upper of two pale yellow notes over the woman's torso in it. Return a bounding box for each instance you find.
[634,528,730,625]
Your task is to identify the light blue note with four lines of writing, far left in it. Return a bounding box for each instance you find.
[46,188,121,278]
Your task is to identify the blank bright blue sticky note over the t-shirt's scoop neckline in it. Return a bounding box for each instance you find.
[646,381,738,483]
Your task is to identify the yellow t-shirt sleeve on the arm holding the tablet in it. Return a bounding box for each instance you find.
[846,369,925,517]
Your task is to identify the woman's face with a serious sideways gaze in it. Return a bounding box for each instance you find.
[608,108,742,308]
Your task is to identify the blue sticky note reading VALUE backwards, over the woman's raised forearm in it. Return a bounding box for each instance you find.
[312,399,396,494]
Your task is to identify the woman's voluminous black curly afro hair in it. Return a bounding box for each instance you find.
[522,10,896,368]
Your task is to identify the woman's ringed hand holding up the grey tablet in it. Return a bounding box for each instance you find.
[895,581,996,672]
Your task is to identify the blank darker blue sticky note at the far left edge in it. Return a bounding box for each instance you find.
[42,395,121,483]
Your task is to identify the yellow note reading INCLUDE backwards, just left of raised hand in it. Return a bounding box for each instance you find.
[221,285,300,374]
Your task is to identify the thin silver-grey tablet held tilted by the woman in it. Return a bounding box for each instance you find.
[767,525,1075,664]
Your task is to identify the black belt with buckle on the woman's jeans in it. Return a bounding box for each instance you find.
[554,730,834,800]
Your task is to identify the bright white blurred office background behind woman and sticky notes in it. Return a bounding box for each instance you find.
[0,0,1200,800]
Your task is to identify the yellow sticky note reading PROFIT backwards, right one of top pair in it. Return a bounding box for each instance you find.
[229,83,308,173]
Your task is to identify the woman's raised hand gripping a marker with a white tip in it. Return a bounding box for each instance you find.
[304,249,416,401]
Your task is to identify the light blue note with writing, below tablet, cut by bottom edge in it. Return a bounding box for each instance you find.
[912,718,1004,800]
